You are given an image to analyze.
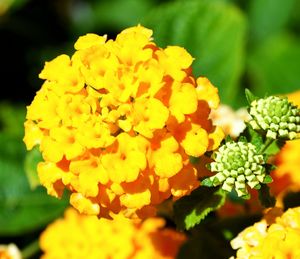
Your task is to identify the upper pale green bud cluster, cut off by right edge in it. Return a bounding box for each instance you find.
[249,96,300,139]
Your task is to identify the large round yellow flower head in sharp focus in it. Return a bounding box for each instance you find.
[24,26,224,218]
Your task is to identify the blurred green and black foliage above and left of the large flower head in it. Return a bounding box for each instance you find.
[0,0,300,258]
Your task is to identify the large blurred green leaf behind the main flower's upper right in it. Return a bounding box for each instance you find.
[143,0,246,105]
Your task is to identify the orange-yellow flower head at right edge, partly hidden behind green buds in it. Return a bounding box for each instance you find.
[271,91,300,195]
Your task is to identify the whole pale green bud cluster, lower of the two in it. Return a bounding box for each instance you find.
[202,141,272,196]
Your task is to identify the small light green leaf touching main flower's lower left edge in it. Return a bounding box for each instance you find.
[24,147,43,189]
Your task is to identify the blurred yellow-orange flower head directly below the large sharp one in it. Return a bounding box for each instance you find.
[40,209,185,259]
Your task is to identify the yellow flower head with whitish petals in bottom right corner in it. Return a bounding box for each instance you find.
[231,207,300,259]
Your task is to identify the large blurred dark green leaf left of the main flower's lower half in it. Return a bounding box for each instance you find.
[0,131,68,236]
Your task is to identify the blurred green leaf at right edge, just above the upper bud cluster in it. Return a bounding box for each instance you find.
[248,34,300,96]
